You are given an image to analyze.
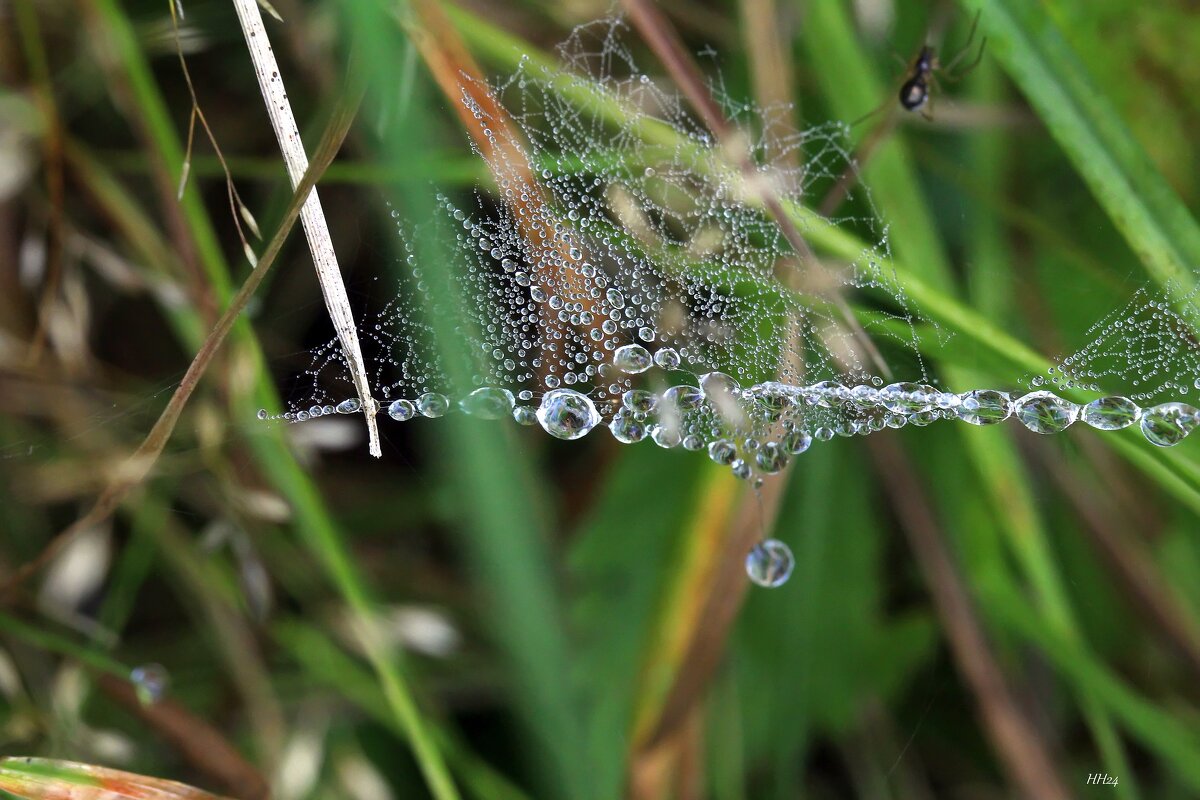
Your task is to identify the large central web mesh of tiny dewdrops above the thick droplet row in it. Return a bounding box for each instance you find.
[285,18,928,422]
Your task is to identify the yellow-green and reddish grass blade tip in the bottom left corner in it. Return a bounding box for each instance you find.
[0,758,230,800]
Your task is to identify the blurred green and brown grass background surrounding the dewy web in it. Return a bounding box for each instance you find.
[0,0,1200,800]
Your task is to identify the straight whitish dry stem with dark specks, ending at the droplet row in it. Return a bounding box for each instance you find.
[233,0,383,458]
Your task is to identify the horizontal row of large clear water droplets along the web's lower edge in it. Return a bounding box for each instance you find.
[270,344,1200,455]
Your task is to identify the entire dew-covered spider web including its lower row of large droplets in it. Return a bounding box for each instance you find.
[272,19,1200,489]
